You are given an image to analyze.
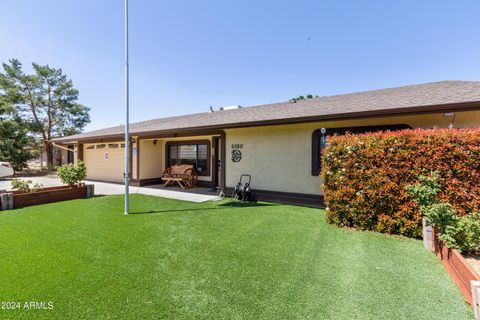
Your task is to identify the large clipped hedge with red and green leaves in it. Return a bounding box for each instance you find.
[322,129,480,237]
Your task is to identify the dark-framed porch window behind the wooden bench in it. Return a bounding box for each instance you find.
[167,141,210,176]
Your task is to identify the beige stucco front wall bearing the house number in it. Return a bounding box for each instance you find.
[225,111,480,195]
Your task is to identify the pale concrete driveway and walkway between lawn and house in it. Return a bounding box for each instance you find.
[0,176,220,202]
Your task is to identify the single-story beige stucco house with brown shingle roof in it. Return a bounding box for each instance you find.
[56,81,480,204]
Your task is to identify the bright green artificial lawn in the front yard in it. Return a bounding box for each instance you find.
[0,195,473,320]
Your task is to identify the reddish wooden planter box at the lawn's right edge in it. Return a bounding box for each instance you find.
[433,230,480,304]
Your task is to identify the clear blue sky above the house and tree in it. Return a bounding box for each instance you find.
[0,0,480,130]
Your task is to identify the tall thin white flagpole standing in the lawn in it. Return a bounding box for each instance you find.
[124,0,130,214]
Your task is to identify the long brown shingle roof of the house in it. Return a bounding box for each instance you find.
[57,81,480,142]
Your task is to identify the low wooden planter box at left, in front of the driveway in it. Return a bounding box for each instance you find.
[0,184,94,210]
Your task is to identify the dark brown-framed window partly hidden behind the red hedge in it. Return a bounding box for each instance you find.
[312,124,411,176]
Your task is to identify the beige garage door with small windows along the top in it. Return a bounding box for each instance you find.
[83,142,125,182]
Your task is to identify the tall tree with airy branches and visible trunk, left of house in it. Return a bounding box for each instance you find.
[0,59,90,170]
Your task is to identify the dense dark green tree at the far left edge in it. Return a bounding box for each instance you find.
[0,99,35,171]
